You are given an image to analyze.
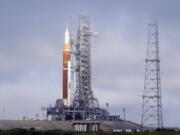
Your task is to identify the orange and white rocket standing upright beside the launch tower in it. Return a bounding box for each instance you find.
[62,24,71,106]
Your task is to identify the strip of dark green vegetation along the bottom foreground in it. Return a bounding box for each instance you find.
[0,129,180,135]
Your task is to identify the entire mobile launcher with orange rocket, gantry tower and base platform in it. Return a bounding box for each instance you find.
[47,15,120,121]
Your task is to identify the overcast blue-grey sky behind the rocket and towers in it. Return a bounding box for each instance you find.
[0,0,180,126]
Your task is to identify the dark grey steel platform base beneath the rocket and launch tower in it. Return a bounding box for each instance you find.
[47,99,120,121]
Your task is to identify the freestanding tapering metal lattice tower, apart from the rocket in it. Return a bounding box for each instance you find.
[141,23,163,128]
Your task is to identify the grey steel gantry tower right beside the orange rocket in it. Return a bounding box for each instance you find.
[73,15,99,110]
